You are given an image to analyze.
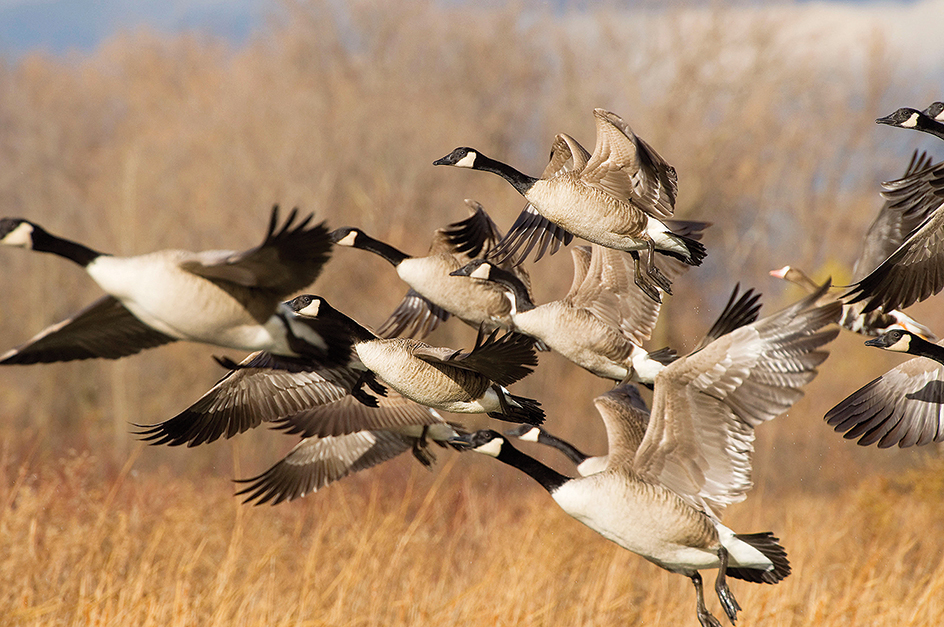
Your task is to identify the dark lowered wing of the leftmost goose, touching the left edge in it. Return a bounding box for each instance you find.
[0,296,177,364]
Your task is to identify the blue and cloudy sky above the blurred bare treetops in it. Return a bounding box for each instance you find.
[0,0,944,69]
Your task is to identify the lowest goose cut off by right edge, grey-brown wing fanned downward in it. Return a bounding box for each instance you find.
[826,329,944,448]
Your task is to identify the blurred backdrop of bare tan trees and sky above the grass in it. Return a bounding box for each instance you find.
[0,0,944,620]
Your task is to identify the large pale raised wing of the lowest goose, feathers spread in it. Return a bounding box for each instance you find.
[634,286,842,517]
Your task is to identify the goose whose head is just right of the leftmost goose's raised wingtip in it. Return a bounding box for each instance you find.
[331,200,530,338]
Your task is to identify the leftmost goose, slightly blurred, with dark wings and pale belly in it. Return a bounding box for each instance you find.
[0,207,331,364]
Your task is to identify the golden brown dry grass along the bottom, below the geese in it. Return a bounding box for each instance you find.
[0,432,944,626]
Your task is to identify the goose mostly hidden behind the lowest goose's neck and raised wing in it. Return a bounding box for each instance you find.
[505,383,649,477]
